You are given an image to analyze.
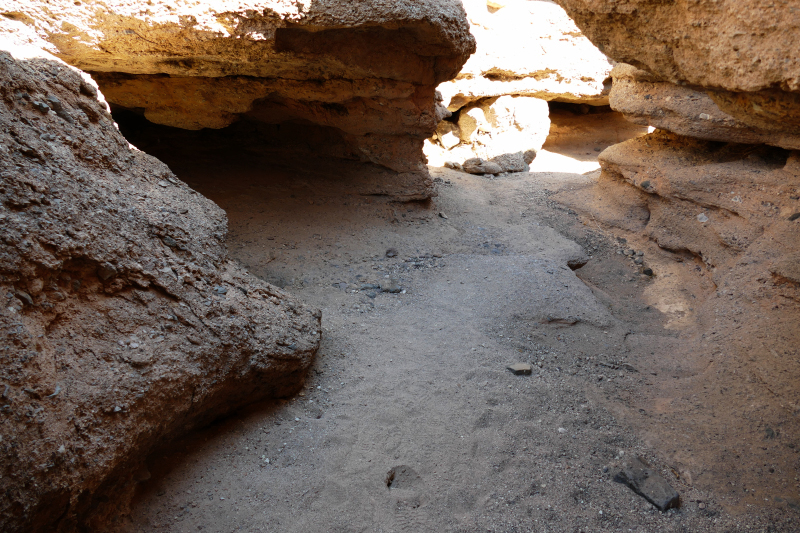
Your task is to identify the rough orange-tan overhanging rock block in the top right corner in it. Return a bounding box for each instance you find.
[557,0,800,145]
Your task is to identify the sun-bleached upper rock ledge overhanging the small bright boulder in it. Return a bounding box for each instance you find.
[439,0,611,111]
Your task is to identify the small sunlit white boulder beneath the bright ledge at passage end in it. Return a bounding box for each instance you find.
[425,96,550,168]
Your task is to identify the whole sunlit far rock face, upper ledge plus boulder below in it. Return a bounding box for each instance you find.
[425,0,612,172]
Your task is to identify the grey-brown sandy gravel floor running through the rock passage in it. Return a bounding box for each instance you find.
[114,117,800,532]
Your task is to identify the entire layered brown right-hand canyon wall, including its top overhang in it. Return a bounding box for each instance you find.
[558,0,800,498]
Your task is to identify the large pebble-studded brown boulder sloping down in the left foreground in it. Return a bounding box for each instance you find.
[0,46,320,532]
